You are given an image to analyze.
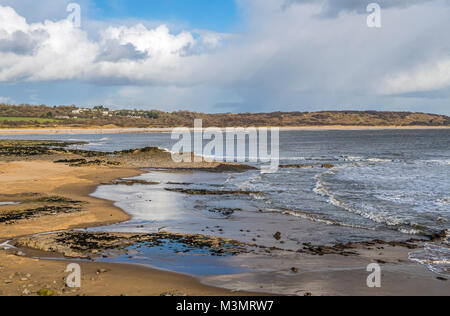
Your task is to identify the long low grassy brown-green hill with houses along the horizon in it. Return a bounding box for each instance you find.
[0,104,450,128]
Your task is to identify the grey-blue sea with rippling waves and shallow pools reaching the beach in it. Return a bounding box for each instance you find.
[1,129,450,294]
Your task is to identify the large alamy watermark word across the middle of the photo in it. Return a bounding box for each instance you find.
[172,119,280,173]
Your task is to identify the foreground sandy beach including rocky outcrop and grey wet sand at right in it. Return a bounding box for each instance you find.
[0,142,450,296]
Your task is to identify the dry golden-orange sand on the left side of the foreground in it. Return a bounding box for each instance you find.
[0,161,256,296]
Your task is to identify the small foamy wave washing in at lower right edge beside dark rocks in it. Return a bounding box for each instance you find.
[409,242,450,276]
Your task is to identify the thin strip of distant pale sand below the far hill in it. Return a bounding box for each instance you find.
[0,125,450,136]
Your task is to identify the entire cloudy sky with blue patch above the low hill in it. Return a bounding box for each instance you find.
[0,0,450,115]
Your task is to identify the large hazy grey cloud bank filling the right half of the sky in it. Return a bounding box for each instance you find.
[224,0,450,113]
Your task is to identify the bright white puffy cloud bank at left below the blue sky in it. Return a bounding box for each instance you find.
[0,6,225,84]
